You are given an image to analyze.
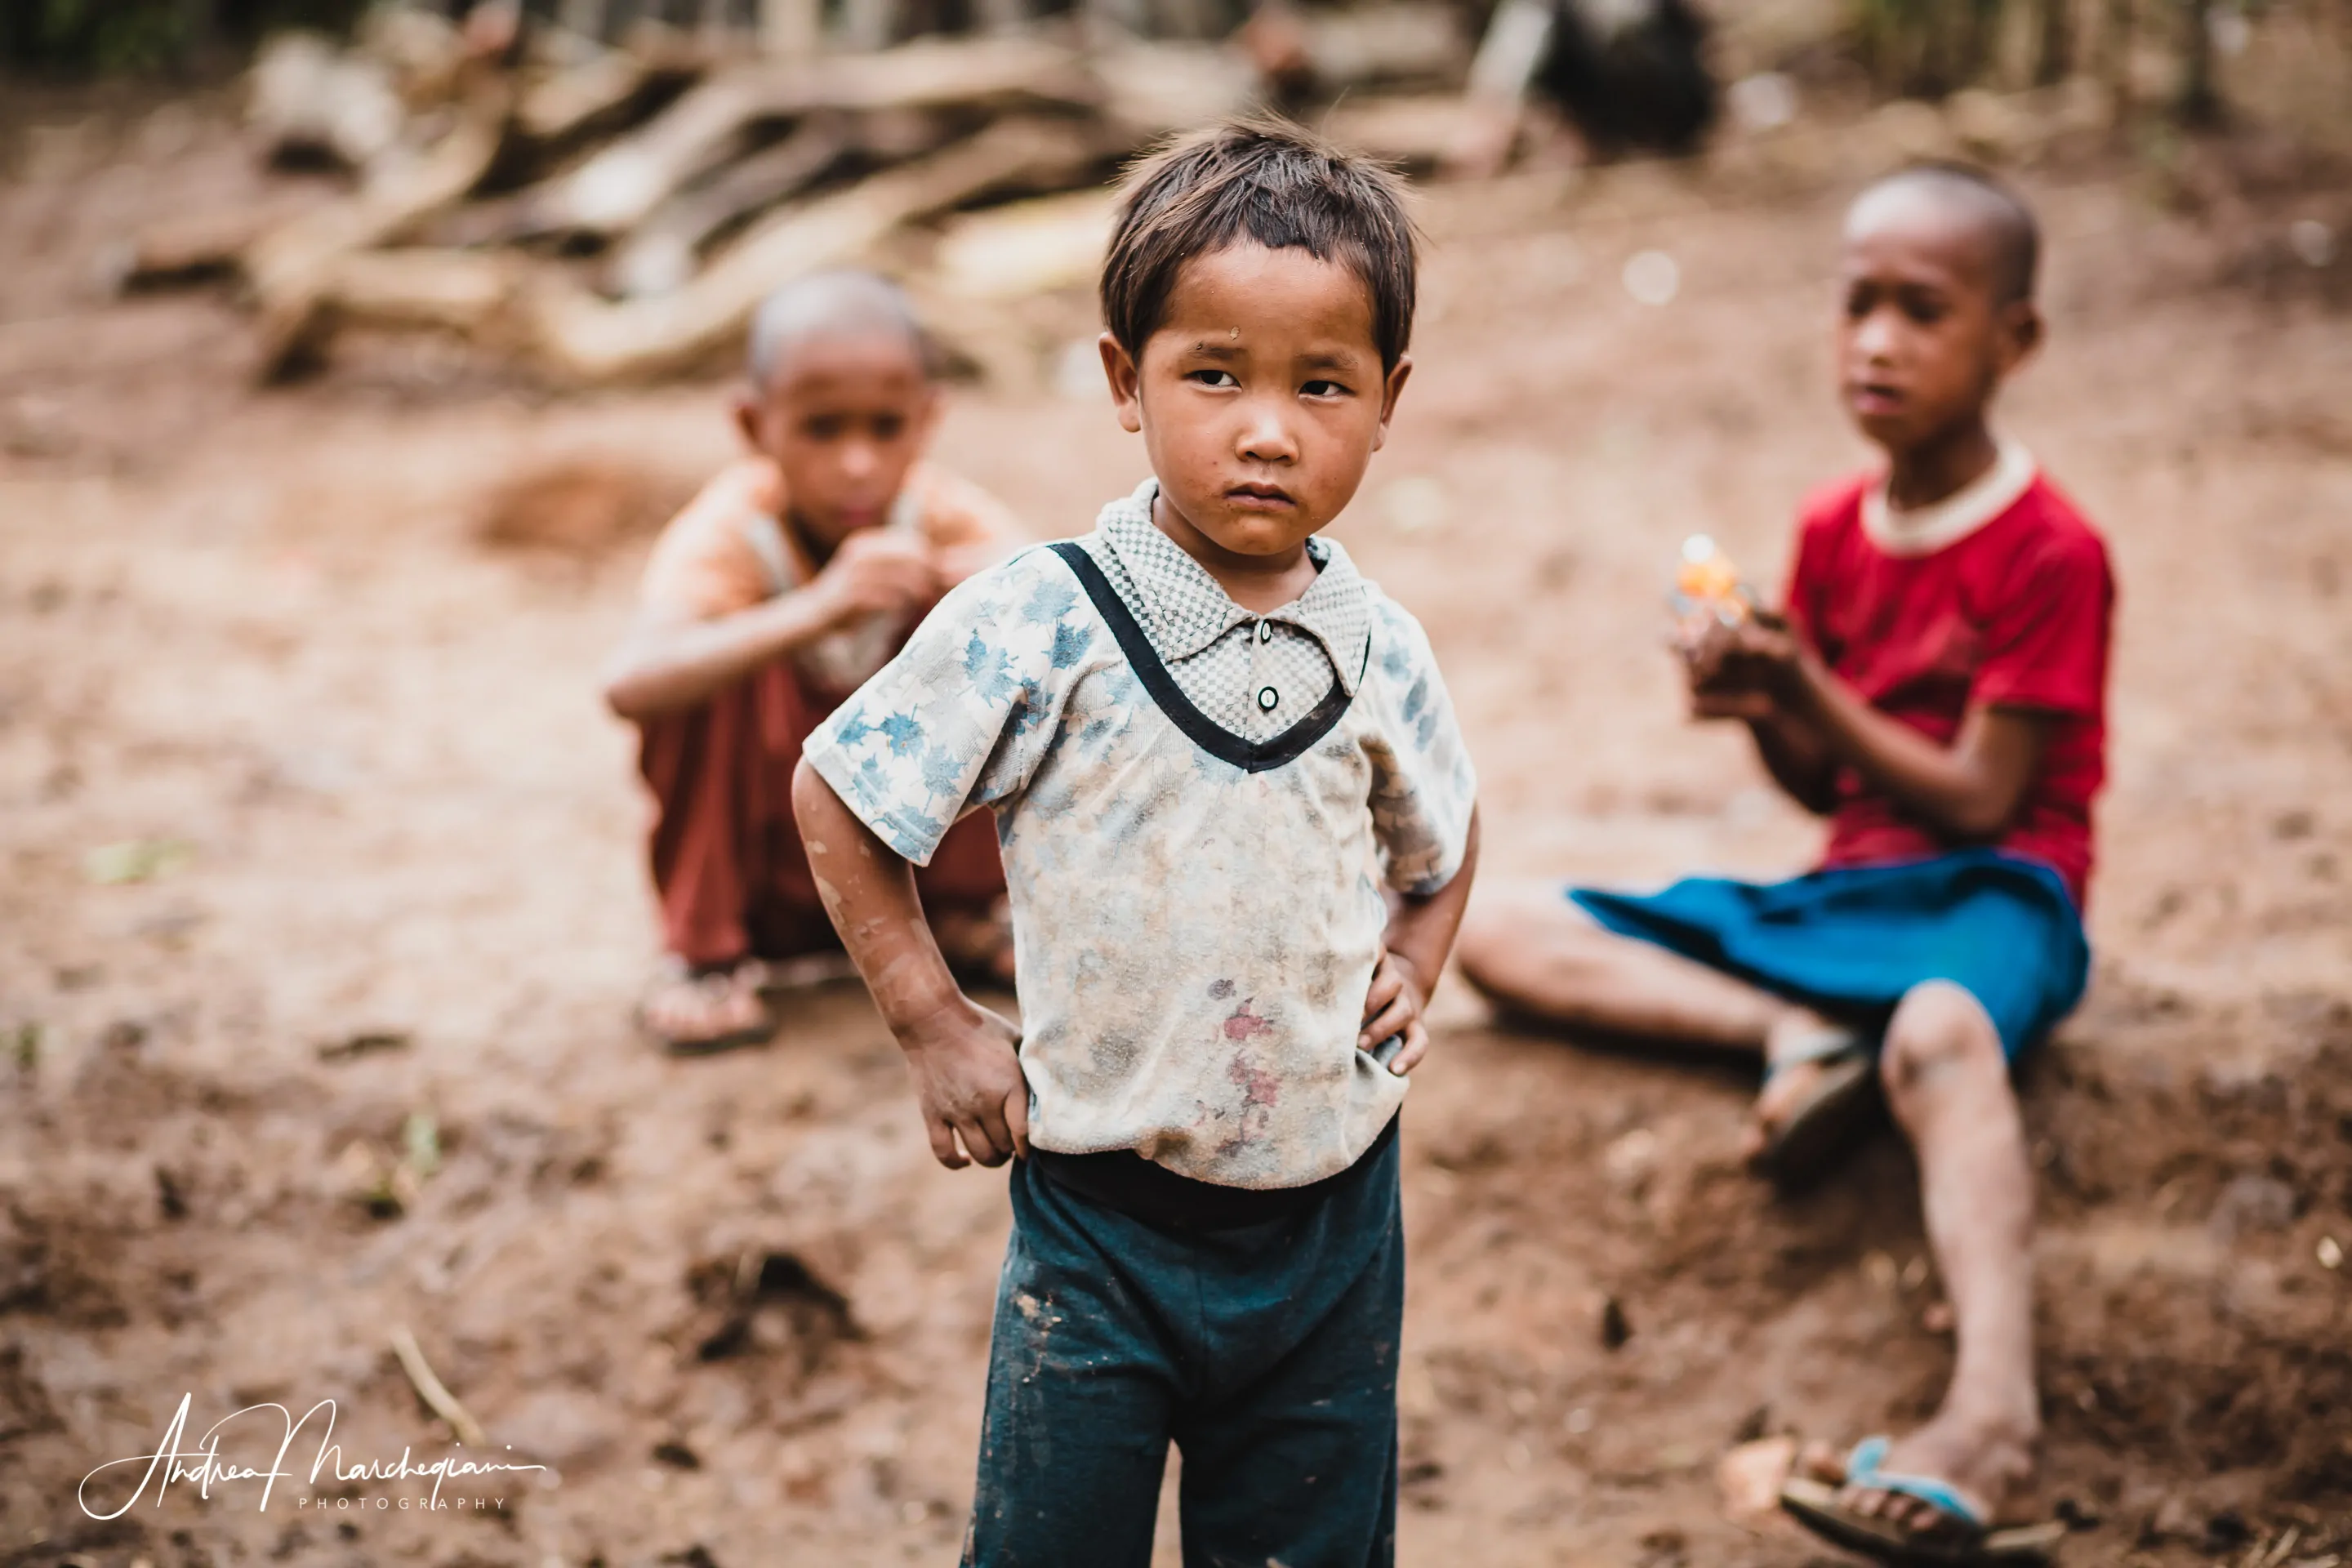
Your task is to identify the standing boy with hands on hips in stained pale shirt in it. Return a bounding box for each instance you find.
[793,125,1475,1568]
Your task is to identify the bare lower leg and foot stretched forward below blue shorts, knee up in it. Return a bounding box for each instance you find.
[1815,980,2042,1526]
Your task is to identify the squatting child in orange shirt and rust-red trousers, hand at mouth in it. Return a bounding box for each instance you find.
[604,273,1018,1051]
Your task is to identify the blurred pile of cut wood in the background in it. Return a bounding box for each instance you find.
[115,2,1468,385]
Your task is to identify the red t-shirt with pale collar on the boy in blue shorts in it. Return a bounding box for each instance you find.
[1788,477,2114,905]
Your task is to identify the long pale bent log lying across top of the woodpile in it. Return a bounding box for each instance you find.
[508,38,1094,238]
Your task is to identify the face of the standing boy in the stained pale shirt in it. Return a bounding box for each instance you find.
[1101,244,1411,555]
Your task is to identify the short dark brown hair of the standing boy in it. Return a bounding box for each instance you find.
[1103,118,1416,372]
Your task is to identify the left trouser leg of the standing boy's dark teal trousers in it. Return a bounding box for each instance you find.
[964,1161,1178,1568]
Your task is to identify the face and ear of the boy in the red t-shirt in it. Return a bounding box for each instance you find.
[1837,185,2042,458]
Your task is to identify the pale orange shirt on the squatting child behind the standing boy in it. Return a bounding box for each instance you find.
[639,456,1026,691]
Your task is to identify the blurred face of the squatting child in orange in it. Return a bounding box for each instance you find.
[736,332,938,550]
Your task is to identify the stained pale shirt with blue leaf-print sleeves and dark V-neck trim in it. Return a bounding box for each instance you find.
[807,482,1477,1187]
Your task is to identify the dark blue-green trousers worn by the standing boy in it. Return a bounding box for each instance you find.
[964,1138,1404,1568]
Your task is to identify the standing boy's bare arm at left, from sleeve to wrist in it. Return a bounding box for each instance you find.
[793,757,964,1044]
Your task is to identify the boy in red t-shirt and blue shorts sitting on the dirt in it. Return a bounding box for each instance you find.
[1460,164,2114,1561]
